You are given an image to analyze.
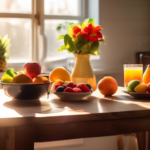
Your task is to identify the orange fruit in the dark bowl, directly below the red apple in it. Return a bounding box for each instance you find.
[12,73,32,83]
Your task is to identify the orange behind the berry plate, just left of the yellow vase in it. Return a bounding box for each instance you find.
[49,67,71,82]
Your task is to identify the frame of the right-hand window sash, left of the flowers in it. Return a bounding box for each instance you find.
[37,0,88,71]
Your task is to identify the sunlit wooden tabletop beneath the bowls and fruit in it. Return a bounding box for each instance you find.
[0,87,150,126]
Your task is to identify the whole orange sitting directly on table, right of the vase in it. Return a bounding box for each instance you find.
[97,76,118,96]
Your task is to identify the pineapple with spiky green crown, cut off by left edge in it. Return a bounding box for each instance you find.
[0,35,10,71]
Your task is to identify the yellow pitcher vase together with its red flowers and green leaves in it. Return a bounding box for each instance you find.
[57,18,105,90]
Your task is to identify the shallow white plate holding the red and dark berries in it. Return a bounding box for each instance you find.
[52,92,92,100]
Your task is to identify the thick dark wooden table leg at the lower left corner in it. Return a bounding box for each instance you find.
[0,126,34,150]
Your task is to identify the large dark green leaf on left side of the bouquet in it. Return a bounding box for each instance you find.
[64,34,77,52]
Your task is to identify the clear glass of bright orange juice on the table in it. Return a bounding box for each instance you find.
[124,64,143,87]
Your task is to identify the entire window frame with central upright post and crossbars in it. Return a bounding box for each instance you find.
[0,0,100,72]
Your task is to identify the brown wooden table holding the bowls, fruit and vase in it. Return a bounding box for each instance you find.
[0,87,150,150]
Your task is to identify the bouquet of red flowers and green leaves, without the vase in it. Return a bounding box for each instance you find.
[57,18,105,55]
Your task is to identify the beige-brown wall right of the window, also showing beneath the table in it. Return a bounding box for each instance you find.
[35,0,150,150]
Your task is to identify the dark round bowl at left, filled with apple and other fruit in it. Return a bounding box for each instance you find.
[0,82,51,100]
